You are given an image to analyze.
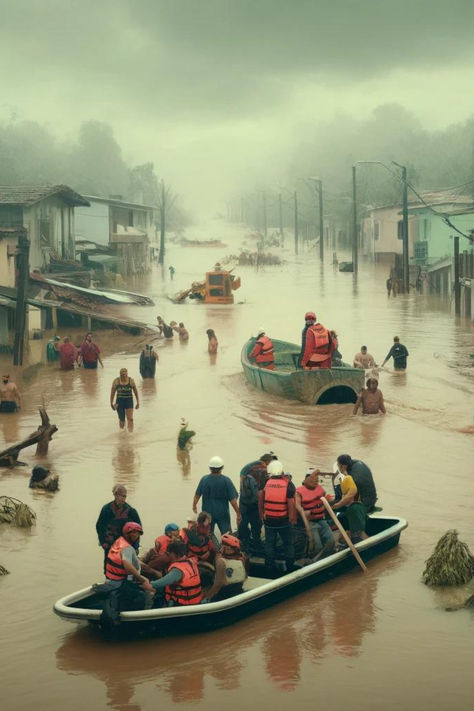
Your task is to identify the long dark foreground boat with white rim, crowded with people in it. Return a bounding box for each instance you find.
[53,515,408,635]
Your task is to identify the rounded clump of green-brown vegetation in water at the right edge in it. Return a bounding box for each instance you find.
[423,529,474,585]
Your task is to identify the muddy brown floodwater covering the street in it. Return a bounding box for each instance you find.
[0,223,474,711]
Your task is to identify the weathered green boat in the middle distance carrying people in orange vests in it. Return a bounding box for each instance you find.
[241,338,365,405]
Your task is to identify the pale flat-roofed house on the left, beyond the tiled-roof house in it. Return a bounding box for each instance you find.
[76,195,156,275]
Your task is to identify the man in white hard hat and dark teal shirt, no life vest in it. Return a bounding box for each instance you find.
[192,456,241,534]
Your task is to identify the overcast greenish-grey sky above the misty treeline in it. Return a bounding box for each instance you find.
[0,0,474,211]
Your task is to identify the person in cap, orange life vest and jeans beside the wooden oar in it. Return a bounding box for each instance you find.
[295,469,335,558]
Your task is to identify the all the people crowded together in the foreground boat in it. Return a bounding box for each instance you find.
[94,452,377,617]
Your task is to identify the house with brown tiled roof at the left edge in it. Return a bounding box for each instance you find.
[0,185,89,272]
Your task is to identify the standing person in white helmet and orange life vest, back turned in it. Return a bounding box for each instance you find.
[258,459,296,573]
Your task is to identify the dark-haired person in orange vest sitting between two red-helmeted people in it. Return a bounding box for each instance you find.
[142,540,202,607]
